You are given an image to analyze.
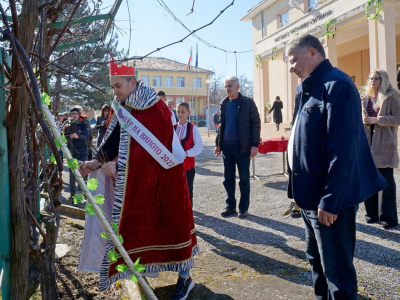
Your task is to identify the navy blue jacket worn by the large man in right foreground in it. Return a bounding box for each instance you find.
[288,60,387,214]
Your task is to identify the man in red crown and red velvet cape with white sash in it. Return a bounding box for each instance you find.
[85,57,199,299]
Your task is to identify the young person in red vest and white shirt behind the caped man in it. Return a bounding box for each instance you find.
[174,102,203,208]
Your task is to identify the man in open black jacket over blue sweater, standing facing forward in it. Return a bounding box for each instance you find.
[214,76,261,218]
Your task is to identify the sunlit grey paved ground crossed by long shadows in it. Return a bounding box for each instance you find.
[58,129,400,299]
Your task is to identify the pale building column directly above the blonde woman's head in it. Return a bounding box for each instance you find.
[368,1,396,86]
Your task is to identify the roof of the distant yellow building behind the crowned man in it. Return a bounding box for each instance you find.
[128,57,213,74]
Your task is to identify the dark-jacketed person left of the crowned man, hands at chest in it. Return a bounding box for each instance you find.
[63,107,89,203]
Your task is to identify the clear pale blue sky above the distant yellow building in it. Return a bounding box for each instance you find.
[102,0,260,81]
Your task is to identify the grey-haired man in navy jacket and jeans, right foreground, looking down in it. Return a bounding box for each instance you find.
[285,35,386,300]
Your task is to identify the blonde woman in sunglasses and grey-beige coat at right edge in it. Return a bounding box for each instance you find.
[361,70,400,229]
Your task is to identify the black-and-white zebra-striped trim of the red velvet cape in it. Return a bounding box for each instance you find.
[99,82,199,291]
